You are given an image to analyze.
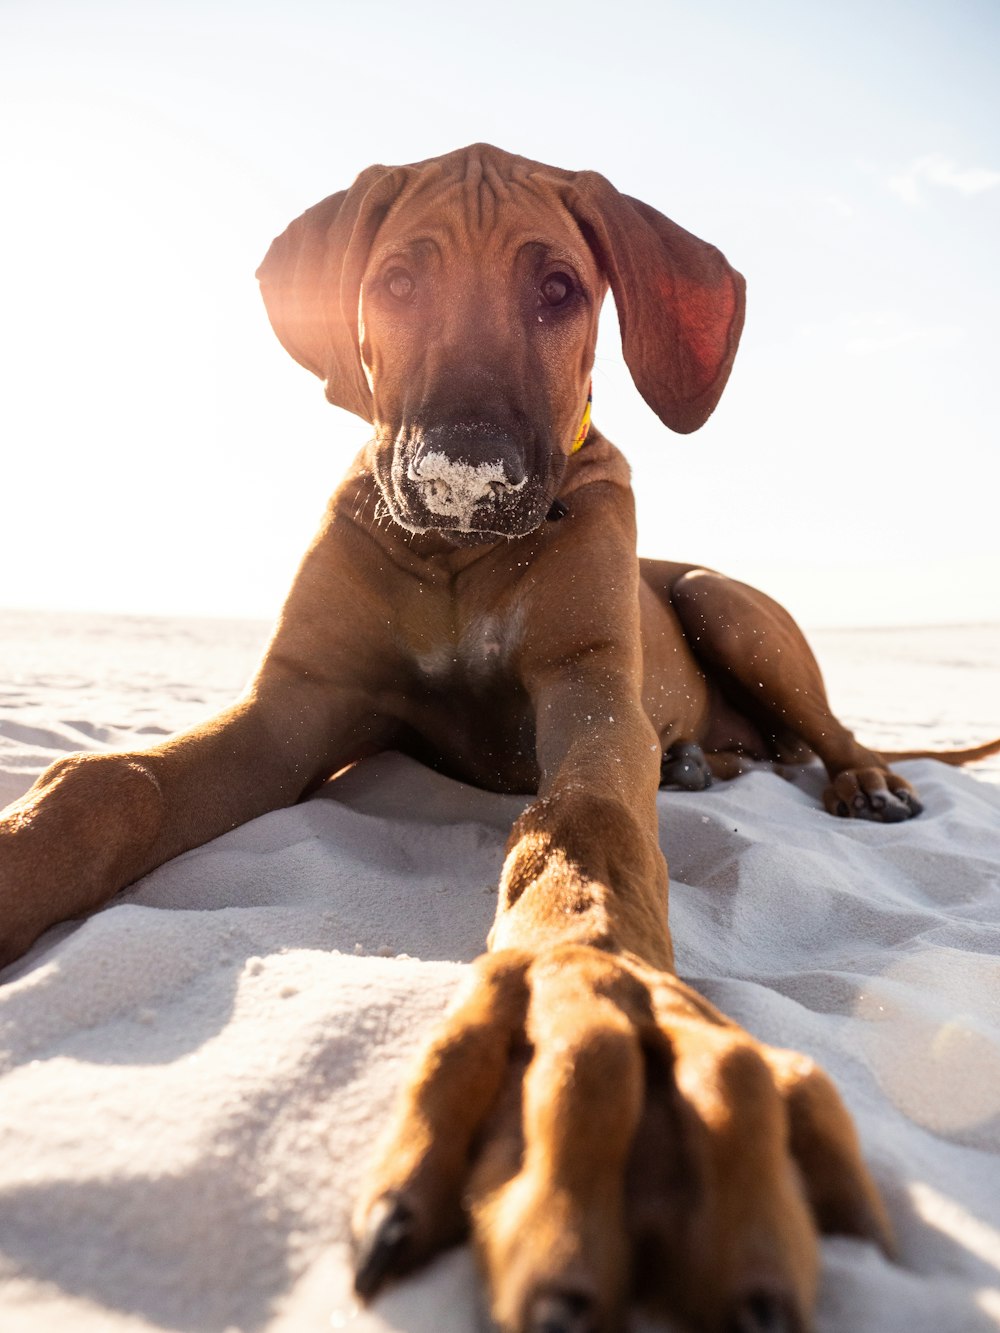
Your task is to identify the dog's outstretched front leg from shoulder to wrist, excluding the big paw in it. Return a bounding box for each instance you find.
[489,484,673,969]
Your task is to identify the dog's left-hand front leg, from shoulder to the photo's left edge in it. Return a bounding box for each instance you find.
[0,501,413,966]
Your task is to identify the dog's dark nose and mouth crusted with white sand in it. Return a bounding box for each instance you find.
[376,424,551,545]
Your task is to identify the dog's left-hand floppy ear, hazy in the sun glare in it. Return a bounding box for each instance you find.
[257,167,409,421]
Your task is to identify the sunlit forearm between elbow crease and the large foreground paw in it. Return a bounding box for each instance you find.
[489,644,673,969]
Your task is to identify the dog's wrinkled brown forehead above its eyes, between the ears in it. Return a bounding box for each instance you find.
[371,168,600,281]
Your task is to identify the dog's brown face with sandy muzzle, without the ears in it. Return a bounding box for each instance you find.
[360,181,608,544]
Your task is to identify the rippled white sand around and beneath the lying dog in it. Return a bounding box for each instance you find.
[0,613,1000,1333]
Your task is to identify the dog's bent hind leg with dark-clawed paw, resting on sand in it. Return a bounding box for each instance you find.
[669,569,921,824]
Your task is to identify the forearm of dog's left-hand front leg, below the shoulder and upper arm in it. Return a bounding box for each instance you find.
[0,664,371,966]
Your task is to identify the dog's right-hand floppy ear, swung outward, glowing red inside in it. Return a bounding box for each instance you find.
[565,172,745,435]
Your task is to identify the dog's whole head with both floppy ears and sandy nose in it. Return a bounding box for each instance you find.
[257,144,744,543]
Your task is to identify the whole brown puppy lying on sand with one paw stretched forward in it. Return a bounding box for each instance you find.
[0,145,996,1333]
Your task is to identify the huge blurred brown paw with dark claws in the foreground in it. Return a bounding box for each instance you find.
[355,945,889,1333]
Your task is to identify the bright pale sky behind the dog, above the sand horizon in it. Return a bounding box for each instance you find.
[0,0,1000,625]
